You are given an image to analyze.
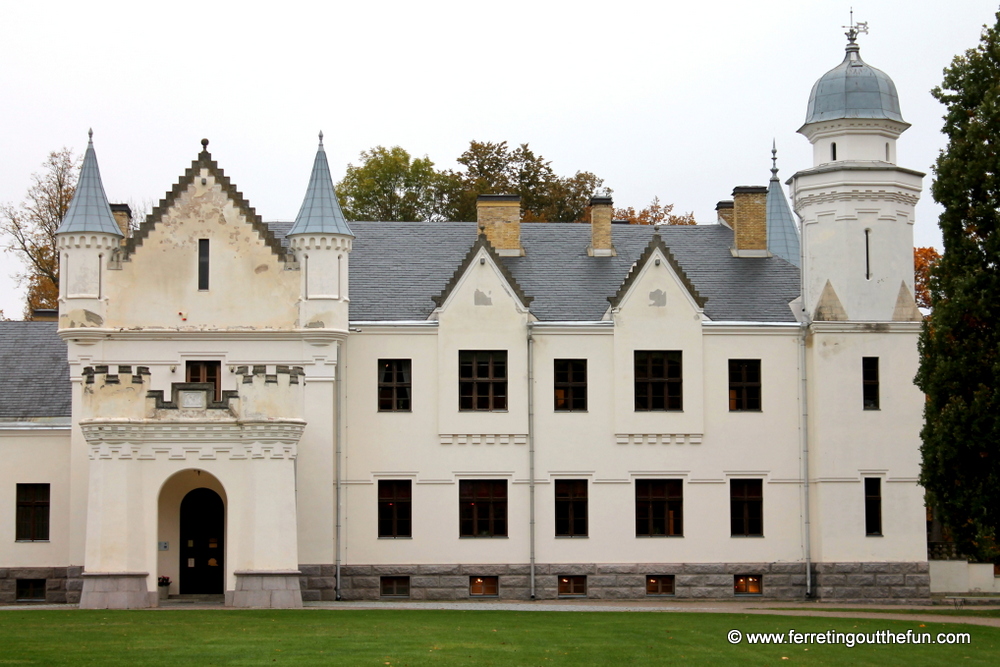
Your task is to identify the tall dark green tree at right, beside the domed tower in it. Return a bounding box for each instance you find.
[916,13,1000,562]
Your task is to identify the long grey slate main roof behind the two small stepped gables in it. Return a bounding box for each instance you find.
[268,222,799,322]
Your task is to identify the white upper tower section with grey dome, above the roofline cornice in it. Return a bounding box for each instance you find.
[789,27,924,322]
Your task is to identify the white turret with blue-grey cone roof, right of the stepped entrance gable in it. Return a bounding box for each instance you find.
[287,132,354,333]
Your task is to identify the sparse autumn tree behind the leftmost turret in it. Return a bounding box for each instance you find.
[0,148,81,320]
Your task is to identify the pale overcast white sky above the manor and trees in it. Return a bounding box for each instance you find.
[0,0,997,317]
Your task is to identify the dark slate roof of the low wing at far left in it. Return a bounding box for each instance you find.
[0,322,71,421]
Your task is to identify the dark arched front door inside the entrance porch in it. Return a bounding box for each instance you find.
[179,487,226,595]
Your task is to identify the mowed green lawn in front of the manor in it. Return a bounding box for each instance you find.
[0,610,1000,667]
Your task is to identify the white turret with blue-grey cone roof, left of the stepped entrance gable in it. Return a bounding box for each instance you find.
[56,130,122,329]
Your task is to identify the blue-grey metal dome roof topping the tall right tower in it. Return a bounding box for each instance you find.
[806,40,905,124]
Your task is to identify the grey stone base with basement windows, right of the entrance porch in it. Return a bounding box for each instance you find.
[299,562,930,603]
